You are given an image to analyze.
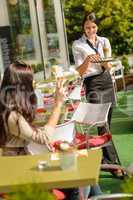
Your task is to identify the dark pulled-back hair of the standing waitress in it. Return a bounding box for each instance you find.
[82,12,99,31]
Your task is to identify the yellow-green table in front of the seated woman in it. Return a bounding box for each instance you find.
[0,148,102,192]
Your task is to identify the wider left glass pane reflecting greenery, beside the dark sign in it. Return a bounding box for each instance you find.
[7,0,35,60]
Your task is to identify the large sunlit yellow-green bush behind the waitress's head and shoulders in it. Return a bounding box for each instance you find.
[64,0,133,61]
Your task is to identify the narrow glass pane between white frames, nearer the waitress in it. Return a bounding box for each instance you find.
[43,0,60,63]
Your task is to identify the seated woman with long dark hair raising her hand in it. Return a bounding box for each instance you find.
[0,61,102,200]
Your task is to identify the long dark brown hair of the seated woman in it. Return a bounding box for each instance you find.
[0,61,37,145]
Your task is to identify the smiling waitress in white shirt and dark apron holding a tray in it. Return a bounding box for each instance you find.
[72,13,122,176]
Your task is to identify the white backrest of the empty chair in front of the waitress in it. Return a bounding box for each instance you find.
[72,102,111,126]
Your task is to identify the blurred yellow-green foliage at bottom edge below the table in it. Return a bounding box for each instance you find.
[6,184,55,200]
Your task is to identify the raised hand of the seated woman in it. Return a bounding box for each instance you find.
[55,77,67,105]
